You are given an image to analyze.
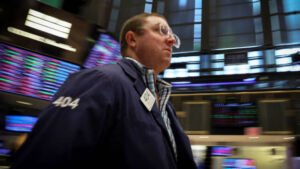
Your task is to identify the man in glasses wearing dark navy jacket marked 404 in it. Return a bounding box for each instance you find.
[12,14,196,169]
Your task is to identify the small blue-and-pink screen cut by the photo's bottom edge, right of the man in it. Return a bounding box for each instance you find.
[222,158,256,169]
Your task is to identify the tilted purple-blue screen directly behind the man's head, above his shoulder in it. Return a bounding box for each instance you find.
[83,33,122,68]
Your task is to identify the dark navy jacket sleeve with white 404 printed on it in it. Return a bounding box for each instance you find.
[12,69,115,169]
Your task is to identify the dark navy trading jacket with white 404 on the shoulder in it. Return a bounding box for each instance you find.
[12,59,196,169]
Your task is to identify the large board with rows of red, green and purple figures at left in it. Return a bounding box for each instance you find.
[0,43,80,100]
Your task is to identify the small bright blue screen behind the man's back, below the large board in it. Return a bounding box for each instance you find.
[5,115,38,132]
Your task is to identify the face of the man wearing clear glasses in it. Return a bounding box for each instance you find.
[135,16,176,74]
